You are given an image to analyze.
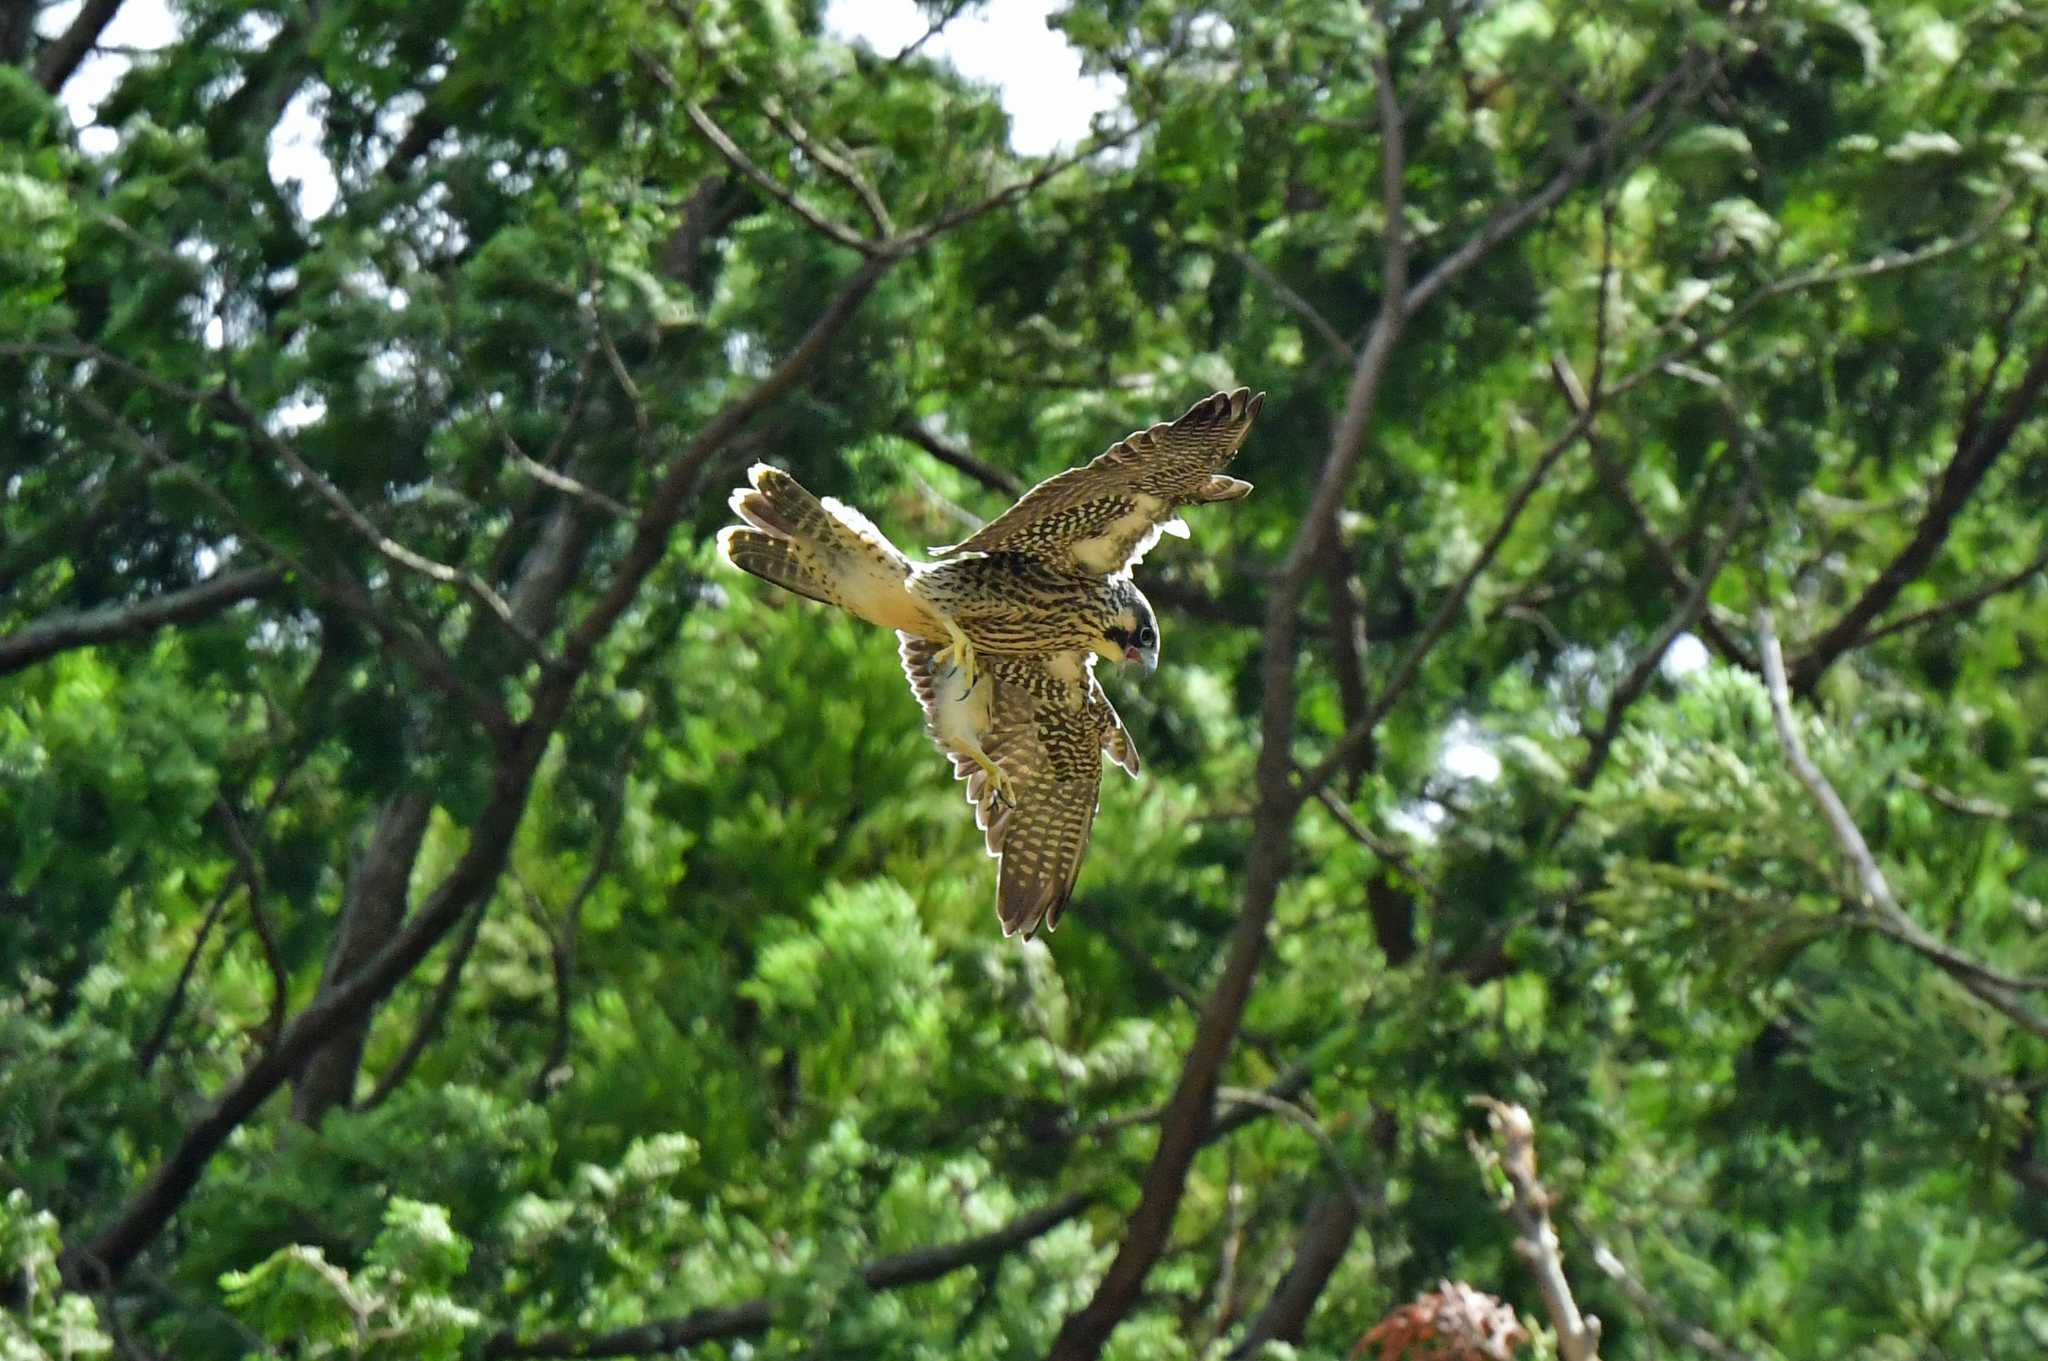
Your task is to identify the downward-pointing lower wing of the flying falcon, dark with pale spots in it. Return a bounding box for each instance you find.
[899,634,1139,937]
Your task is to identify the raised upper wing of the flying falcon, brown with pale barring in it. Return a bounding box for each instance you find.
[932,387,1266,577]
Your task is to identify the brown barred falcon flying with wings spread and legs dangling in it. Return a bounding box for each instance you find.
[719,387,1266,937]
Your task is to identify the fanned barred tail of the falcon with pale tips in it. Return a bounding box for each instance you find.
[719,463,932,632]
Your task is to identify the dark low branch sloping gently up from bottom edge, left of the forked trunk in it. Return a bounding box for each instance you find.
[483,1191,1096,1361]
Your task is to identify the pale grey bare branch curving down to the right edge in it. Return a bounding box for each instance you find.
[1757,606,2048,1038]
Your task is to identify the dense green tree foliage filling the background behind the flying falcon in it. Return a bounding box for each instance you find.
[0,0,2048,1361]
